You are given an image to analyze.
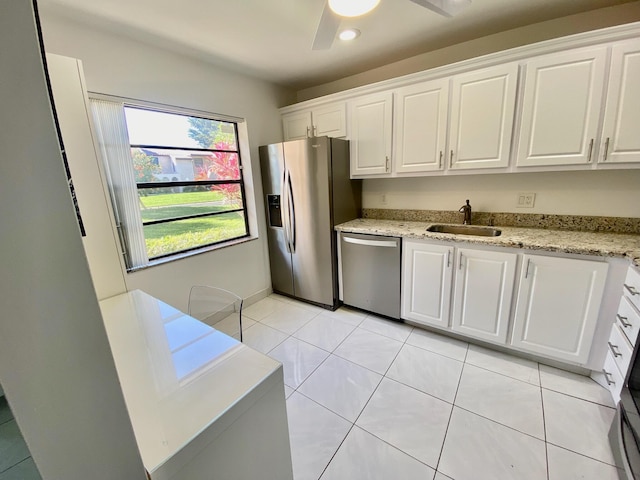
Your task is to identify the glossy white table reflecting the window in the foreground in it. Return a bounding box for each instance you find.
[100,290,293,480]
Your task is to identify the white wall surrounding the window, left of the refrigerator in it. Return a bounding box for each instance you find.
[41,10,292,309]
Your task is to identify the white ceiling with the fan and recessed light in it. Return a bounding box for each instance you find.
[38,0,629,89]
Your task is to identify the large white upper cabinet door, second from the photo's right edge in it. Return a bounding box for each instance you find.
[517,47,607,167]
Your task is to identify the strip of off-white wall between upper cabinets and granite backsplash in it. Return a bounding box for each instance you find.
[362,170,640,217]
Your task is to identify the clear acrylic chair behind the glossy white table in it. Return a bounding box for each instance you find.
[189,285,242,342]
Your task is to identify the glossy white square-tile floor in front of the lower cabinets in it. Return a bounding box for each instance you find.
[242,295,619,480]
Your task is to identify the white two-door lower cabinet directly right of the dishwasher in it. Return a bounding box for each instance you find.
[402,240,517,345]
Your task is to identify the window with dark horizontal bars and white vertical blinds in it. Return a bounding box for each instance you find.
[92,100,249,269]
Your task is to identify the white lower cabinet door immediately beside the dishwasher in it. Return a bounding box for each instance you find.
[401,240,453,328]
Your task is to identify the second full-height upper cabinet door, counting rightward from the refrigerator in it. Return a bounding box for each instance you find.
[394,79,449,173]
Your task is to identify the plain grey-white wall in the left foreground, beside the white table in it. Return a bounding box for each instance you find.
[0,1,145,480]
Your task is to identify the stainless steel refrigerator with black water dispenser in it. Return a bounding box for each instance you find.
[260,137,362,309]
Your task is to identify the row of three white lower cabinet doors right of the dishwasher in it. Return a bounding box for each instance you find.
[401,240,612,365]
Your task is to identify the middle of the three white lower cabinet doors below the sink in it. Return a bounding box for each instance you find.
[451,248,518,345]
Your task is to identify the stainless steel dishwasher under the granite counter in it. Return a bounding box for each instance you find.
[340,232,401,319]
